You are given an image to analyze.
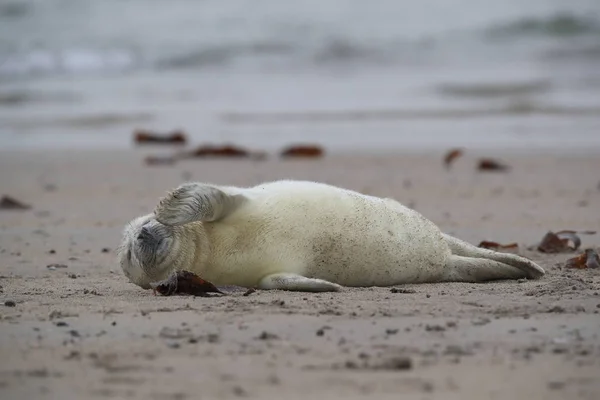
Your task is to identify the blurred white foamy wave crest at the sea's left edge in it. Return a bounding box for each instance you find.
[0,49,138,77]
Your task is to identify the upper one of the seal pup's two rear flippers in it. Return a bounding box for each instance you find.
[444,234,546,279]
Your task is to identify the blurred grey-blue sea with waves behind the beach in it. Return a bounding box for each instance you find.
[0,0,600,152]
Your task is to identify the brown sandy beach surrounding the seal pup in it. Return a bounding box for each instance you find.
[0,151,600,400]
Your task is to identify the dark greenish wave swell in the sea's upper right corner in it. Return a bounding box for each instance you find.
[487,13,600,37]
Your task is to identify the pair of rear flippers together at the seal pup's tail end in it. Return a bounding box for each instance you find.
[444,234,545,282]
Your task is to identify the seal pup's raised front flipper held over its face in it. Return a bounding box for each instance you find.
[154,183,245,226]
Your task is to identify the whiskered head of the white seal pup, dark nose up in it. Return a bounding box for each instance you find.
[117,214,195,289]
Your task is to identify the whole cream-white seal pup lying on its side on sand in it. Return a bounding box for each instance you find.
[119,181,544,291]
